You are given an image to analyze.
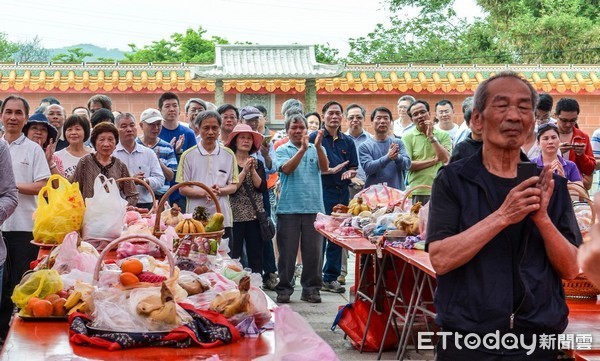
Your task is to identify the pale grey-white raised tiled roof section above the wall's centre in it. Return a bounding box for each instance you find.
[192,45,344,79]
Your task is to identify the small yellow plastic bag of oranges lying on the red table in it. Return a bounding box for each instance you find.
[11,269,63,308]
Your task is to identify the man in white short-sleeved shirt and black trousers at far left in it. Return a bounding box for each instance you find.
[0,95,50,337]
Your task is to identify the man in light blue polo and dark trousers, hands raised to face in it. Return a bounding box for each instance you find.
[275,113,329,303]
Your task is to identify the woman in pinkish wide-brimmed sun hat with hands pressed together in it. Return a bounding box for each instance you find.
[225,124,267,274]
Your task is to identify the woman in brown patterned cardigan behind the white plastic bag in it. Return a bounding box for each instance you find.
[69,122,138,206]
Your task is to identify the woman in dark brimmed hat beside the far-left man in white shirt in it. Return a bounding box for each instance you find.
[23,113,65,175]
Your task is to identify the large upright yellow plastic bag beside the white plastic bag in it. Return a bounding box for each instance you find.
[33,174,85,244]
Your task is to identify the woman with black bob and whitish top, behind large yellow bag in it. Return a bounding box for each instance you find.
[56,115,92,178]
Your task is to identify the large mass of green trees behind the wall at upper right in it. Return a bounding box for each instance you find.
[360,0,600,64]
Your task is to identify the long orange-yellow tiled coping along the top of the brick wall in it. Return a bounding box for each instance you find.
[0,63,600,94]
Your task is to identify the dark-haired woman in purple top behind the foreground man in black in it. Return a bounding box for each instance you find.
[533,123,583,187]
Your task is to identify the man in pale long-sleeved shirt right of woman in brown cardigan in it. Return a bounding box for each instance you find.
[113,113,165,209]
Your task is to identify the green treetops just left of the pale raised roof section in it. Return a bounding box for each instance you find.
[124,26,229,63]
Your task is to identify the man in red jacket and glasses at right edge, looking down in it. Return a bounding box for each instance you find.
[554,98,596,190]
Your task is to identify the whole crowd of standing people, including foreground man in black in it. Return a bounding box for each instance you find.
[0,74,600,359]
